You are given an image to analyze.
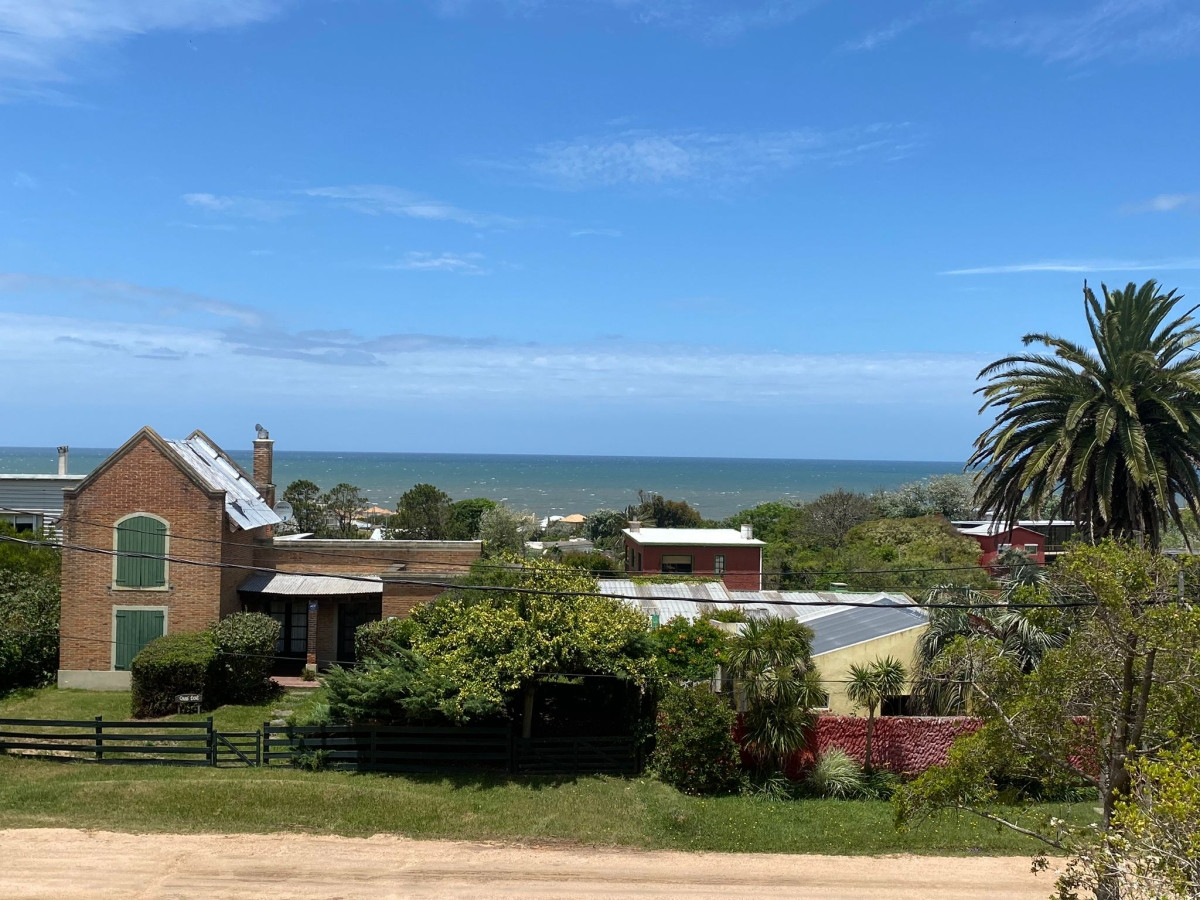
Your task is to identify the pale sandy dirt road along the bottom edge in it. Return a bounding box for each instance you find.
[0,828,1052,900]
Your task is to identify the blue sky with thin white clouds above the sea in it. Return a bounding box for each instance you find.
[0,0,1200,460]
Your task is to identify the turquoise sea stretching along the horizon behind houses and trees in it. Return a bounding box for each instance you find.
[0,448,962,518]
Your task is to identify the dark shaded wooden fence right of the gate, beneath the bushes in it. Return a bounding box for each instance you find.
[263,725,644,775]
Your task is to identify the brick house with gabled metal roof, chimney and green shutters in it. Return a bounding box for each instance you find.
[59,427,480,690]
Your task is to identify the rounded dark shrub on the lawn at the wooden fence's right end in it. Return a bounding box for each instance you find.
[650,685,742,794]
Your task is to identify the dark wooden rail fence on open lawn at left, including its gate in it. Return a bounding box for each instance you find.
[0,715,262,766]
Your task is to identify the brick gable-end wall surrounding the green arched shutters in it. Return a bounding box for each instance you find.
[59,437,224,671]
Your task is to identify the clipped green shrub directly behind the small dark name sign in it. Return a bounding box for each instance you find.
[131,631,217,719]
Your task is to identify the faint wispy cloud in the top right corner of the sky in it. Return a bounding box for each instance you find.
[974,0,1200,64]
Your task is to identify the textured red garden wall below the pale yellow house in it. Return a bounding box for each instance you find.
[788,715,983,775]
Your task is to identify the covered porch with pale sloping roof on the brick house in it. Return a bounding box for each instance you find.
[238,572,383,676]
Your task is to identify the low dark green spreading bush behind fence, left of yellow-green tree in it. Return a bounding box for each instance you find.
[325,650,506,725]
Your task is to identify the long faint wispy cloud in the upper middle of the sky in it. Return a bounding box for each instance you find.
[499,124,916,188]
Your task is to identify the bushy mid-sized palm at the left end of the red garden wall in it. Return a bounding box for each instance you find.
[728,617,824,772]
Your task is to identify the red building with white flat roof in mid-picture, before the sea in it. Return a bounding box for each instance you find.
[623,522,767,590]
